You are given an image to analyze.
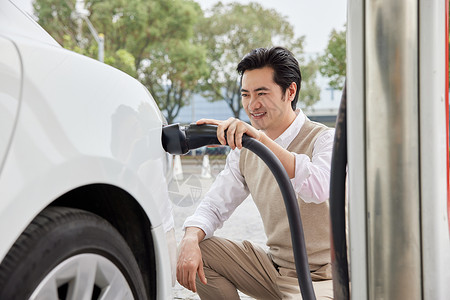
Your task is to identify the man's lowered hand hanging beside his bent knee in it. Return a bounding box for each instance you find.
[177,227,206,293]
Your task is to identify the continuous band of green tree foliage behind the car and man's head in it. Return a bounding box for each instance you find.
[33,0,320,122]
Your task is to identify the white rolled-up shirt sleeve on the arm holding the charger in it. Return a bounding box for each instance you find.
[291,129,334,203]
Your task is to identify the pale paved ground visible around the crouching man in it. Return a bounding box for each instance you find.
[169,157,266,300]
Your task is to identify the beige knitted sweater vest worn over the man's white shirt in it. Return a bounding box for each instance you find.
[239,118,331,280]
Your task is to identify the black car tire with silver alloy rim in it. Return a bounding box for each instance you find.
[0,207,147,299]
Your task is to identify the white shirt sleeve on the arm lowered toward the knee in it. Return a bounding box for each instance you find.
[183,148,249,238]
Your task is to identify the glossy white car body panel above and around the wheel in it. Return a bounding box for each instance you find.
[0,38,173,264]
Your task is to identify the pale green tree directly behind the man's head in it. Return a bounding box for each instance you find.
[197,2,320,118]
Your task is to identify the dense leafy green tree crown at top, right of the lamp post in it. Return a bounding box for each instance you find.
[86,0,202,70]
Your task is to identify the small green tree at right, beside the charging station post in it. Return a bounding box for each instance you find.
[319,29,346,90]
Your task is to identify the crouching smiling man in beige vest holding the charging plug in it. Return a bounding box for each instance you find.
[177,47,334,300]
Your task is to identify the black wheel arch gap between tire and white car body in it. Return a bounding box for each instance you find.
[49,184,157,299]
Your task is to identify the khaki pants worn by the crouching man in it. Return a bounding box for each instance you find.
[196,237,333,300]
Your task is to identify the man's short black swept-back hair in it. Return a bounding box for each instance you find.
[236,47,302,110]
